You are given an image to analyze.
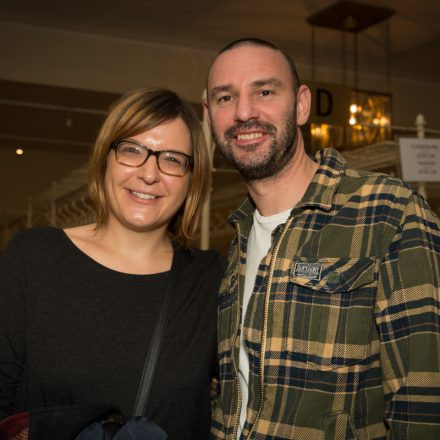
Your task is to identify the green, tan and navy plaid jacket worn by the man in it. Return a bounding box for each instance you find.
[211,149,440,440]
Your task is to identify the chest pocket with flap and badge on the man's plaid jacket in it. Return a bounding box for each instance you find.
[288,257,377,370]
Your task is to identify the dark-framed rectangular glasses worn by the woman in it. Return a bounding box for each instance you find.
[112,139,194,176]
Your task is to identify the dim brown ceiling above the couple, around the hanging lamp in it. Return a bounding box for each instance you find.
[0,0,440,82]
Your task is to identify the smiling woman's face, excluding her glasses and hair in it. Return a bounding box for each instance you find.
[104,118,192,232]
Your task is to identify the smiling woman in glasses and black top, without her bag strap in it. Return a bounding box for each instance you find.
[0,89,223,440]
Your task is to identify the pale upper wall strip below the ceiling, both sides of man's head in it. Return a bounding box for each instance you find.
[0,21,440,129]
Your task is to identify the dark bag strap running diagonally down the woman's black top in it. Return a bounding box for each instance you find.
[133,249,181,417]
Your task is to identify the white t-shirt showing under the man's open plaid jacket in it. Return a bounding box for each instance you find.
[239,209,291,436]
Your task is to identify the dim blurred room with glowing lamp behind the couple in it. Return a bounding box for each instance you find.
[0,0,440,251]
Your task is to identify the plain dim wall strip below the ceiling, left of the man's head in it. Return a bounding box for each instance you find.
[0,21,214,102]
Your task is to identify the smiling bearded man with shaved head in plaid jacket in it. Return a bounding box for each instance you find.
[205,39,440,440]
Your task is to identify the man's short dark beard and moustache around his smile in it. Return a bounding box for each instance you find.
[212,112,298,182]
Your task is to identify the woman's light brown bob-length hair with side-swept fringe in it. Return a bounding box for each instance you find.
[89,88,211,247]
